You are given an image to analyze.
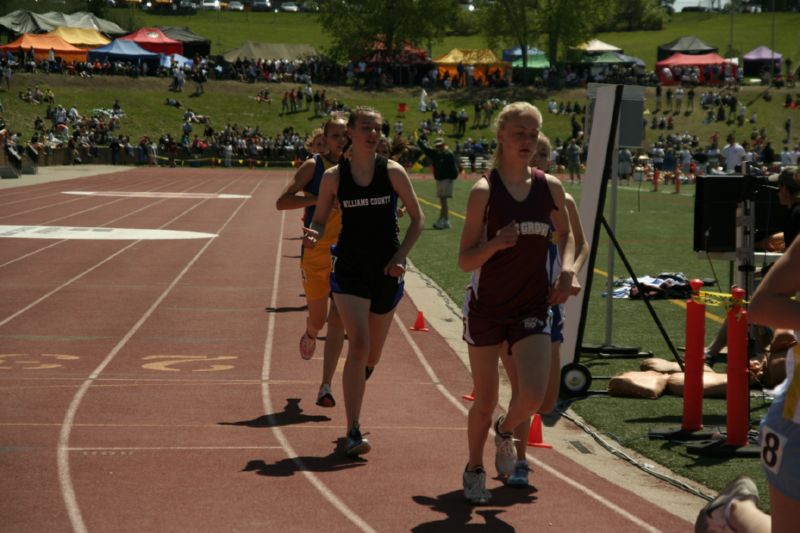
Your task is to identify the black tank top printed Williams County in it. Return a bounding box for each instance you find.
[333,156,400,267]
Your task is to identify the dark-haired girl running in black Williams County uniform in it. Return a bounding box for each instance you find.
[305,107,424,456]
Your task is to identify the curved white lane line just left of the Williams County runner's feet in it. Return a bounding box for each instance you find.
[261,211,375,532]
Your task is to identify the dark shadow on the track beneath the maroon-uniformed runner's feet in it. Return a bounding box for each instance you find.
[411,486,537,533]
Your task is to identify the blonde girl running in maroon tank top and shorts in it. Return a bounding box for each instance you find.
[458,102,574,503]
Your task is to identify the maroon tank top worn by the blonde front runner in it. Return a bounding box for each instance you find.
[469,169,556,321]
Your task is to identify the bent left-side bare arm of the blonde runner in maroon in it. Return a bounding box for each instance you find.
[458,178,519,272]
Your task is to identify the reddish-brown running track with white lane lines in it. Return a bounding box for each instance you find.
[0,169,691,532]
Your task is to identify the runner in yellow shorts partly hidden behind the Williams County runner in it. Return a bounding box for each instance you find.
[276,117,347,407]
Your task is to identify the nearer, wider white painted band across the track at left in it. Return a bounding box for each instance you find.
[0,225,216,241]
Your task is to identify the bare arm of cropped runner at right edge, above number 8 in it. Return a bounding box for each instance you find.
[747,239,800,330]
